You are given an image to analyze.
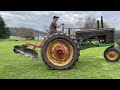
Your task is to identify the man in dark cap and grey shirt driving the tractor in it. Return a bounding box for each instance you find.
[49,16,64,35]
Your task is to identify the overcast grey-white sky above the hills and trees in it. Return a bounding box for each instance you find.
[0,11,120,31]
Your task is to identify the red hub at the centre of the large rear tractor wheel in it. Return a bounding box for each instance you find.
[54,45,66,59]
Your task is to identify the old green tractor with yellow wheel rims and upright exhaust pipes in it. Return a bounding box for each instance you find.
[14,17,120,70]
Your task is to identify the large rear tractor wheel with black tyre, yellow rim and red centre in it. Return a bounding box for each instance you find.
[41,33,80,70]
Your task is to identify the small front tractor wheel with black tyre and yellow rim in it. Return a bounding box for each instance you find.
[104,47,120,62]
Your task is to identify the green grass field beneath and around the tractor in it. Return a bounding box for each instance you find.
[0,40,120,79]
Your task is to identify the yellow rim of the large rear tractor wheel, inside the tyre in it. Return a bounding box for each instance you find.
[46,39,74,66]
